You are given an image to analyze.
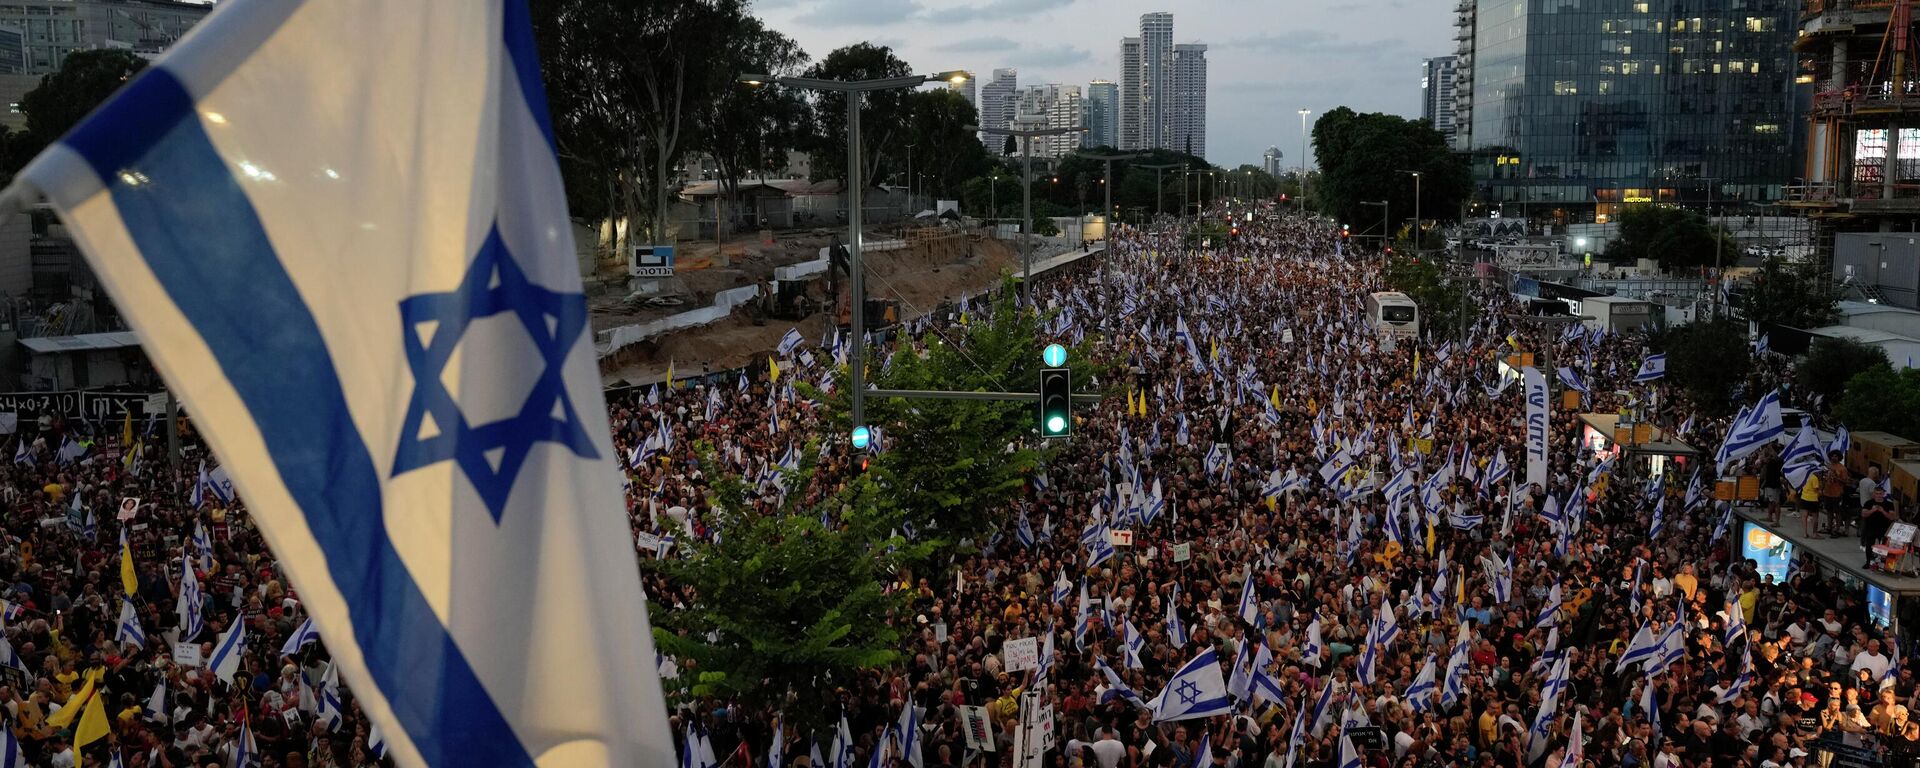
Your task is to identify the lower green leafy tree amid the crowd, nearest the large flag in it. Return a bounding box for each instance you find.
[641,458,927,732]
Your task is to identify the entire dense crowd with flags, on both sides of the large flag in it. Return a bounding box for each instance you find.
[0,210,1920,768]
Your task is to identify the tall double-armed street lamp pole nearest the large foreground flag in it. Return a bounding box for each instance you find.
[739,69,968,430]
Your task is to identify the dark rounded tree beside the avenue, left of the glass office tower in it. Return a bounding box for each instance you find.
[1313,108,1473,234]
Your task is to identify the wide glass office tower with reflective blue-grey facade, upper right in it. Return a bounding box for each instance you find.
[1471,0,1801,223]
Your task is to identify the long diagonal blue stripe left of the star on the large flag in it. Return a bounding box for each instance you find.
[65,70,534,766]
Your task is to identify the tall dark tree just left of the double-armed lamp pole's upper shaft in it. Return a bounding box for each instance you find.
[695,17,808,236]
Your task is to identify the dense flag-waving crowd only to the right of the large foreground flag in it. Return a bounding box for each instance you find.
[614,210,1920,768]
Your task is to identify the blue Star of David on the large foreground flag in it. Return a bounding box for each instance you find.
[394,227,599,524]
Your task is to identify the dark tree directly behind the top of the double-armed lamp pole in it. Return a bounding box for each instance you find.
[806,42,912,186]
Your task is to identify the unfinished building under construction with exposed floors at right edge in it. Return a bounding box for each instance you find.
[1782,0,1920,307]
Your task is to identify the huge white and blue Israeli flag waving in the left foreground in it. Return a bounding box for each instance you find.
[15,0,674,768]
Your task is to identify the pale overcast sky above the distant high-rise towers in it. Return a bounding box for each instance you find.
[755,0,1453,167]
